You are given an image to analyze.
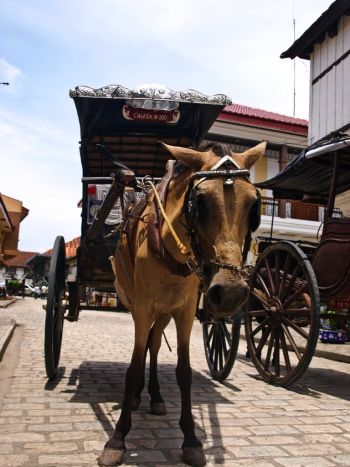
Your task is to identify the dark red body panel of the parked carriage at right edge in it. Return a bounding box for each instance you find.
[312,217,350,300]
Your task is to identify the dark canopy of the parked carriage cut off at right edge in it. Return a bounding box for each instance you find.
[256,135,350,199]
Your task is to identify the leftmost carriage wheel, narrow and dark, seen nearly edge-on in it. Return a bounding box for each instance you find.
[45,236,66,379]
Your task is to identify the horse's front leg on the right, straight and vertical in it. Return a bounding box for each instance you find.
[175,314,206,467]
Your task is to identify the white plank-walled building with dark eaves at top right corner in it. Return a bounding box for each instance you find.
[281,0,350,216]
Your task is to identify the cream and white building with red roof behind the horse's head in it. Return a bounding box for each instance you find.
[207,104,324,258]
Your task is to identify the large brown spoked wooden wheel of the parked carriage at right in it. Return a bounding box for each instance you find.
[245,242,320,386]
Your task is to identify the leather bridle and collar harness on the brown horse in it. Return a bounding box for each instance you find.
[147,155,260,280]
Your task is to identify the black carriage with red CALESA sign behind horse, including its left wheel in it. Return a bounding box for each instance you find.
[45,86,230,378]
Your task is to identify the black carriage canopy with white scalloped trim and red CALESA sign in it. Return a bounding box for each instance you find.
[70,85,230,177]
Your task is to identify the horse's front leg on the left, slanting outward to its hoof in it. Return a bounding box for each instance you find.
[98,320,150,467]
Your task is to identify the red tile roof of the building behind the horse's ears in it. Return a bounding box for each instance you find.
[218,104,308,136]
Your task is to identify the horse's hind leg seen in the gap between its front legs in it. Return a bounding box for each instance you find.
[148,315,171,415]
